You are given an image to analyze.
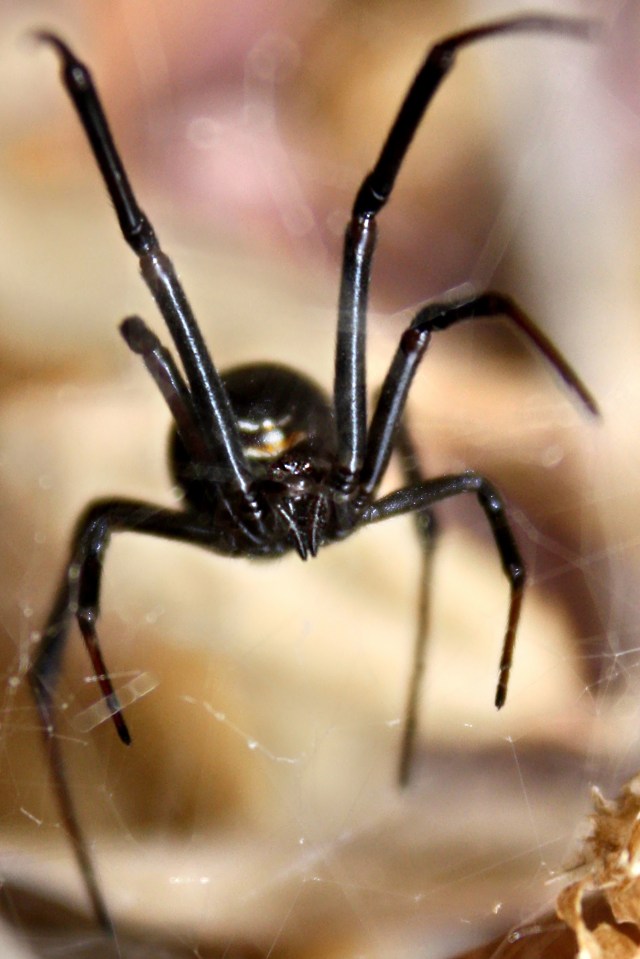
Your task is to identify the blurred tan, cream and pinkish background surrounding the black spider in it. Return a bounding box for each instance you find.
[0,0,640,959]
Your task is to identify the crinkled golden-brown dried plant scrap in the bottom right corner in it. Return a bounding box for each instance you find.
[557,775,640,959]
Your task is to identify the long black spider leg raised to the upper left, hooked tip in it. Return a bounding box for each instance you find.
[36,31,259,522]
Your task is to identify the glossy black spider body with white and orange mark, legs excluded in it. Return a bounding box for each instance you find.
[170,363,336,559]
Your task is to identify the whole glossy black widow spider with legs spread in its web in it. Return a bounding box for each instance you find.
[29,15,597,931]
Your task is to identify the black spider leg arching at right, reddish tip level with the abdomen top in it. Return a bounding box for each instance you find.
[360,292,598,493]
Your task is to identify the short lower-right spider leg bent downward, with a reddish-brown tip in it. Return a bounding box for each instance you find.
[363,472,526,771]
